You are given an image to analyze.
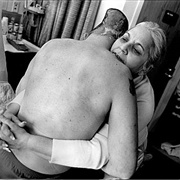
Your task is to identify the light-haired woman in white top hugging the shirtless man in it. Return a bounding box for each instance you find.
[0,19,166,179]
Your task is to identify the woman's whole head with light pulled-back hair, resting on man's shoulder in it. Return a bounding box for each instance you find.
[111,22,166,75]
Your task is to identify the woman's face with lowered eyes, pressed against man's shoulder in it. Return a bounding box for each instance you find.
[111,26,152,73]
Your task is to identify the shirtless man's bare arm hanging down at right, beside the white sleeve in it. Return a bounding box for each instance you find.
[103,68,138,179]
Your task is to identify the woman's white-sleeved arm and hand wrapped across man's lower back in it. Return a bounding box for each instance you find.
[0,118,108,169]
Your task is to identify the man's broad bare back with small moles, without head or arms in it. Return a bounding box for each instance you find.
[13,36,134,174]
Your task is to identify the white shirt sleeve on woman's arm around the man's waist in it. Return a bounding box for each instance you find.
[50,124,108,169]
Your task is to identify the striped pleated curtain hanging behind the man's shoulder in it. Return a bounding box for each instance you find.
[37,0,101,47]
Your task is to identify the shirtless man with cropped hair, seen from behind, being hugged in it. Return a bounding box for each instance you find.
[0,10,137,178]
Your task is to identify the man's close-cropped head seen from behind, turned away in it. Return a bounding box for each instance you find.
[84,8,128,39]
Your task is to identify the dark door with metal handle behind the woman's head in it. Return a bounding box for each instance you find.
[137,0,180,105]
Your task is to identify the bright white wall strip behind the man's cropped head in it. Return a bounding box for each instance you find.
[95,0,144,27]
